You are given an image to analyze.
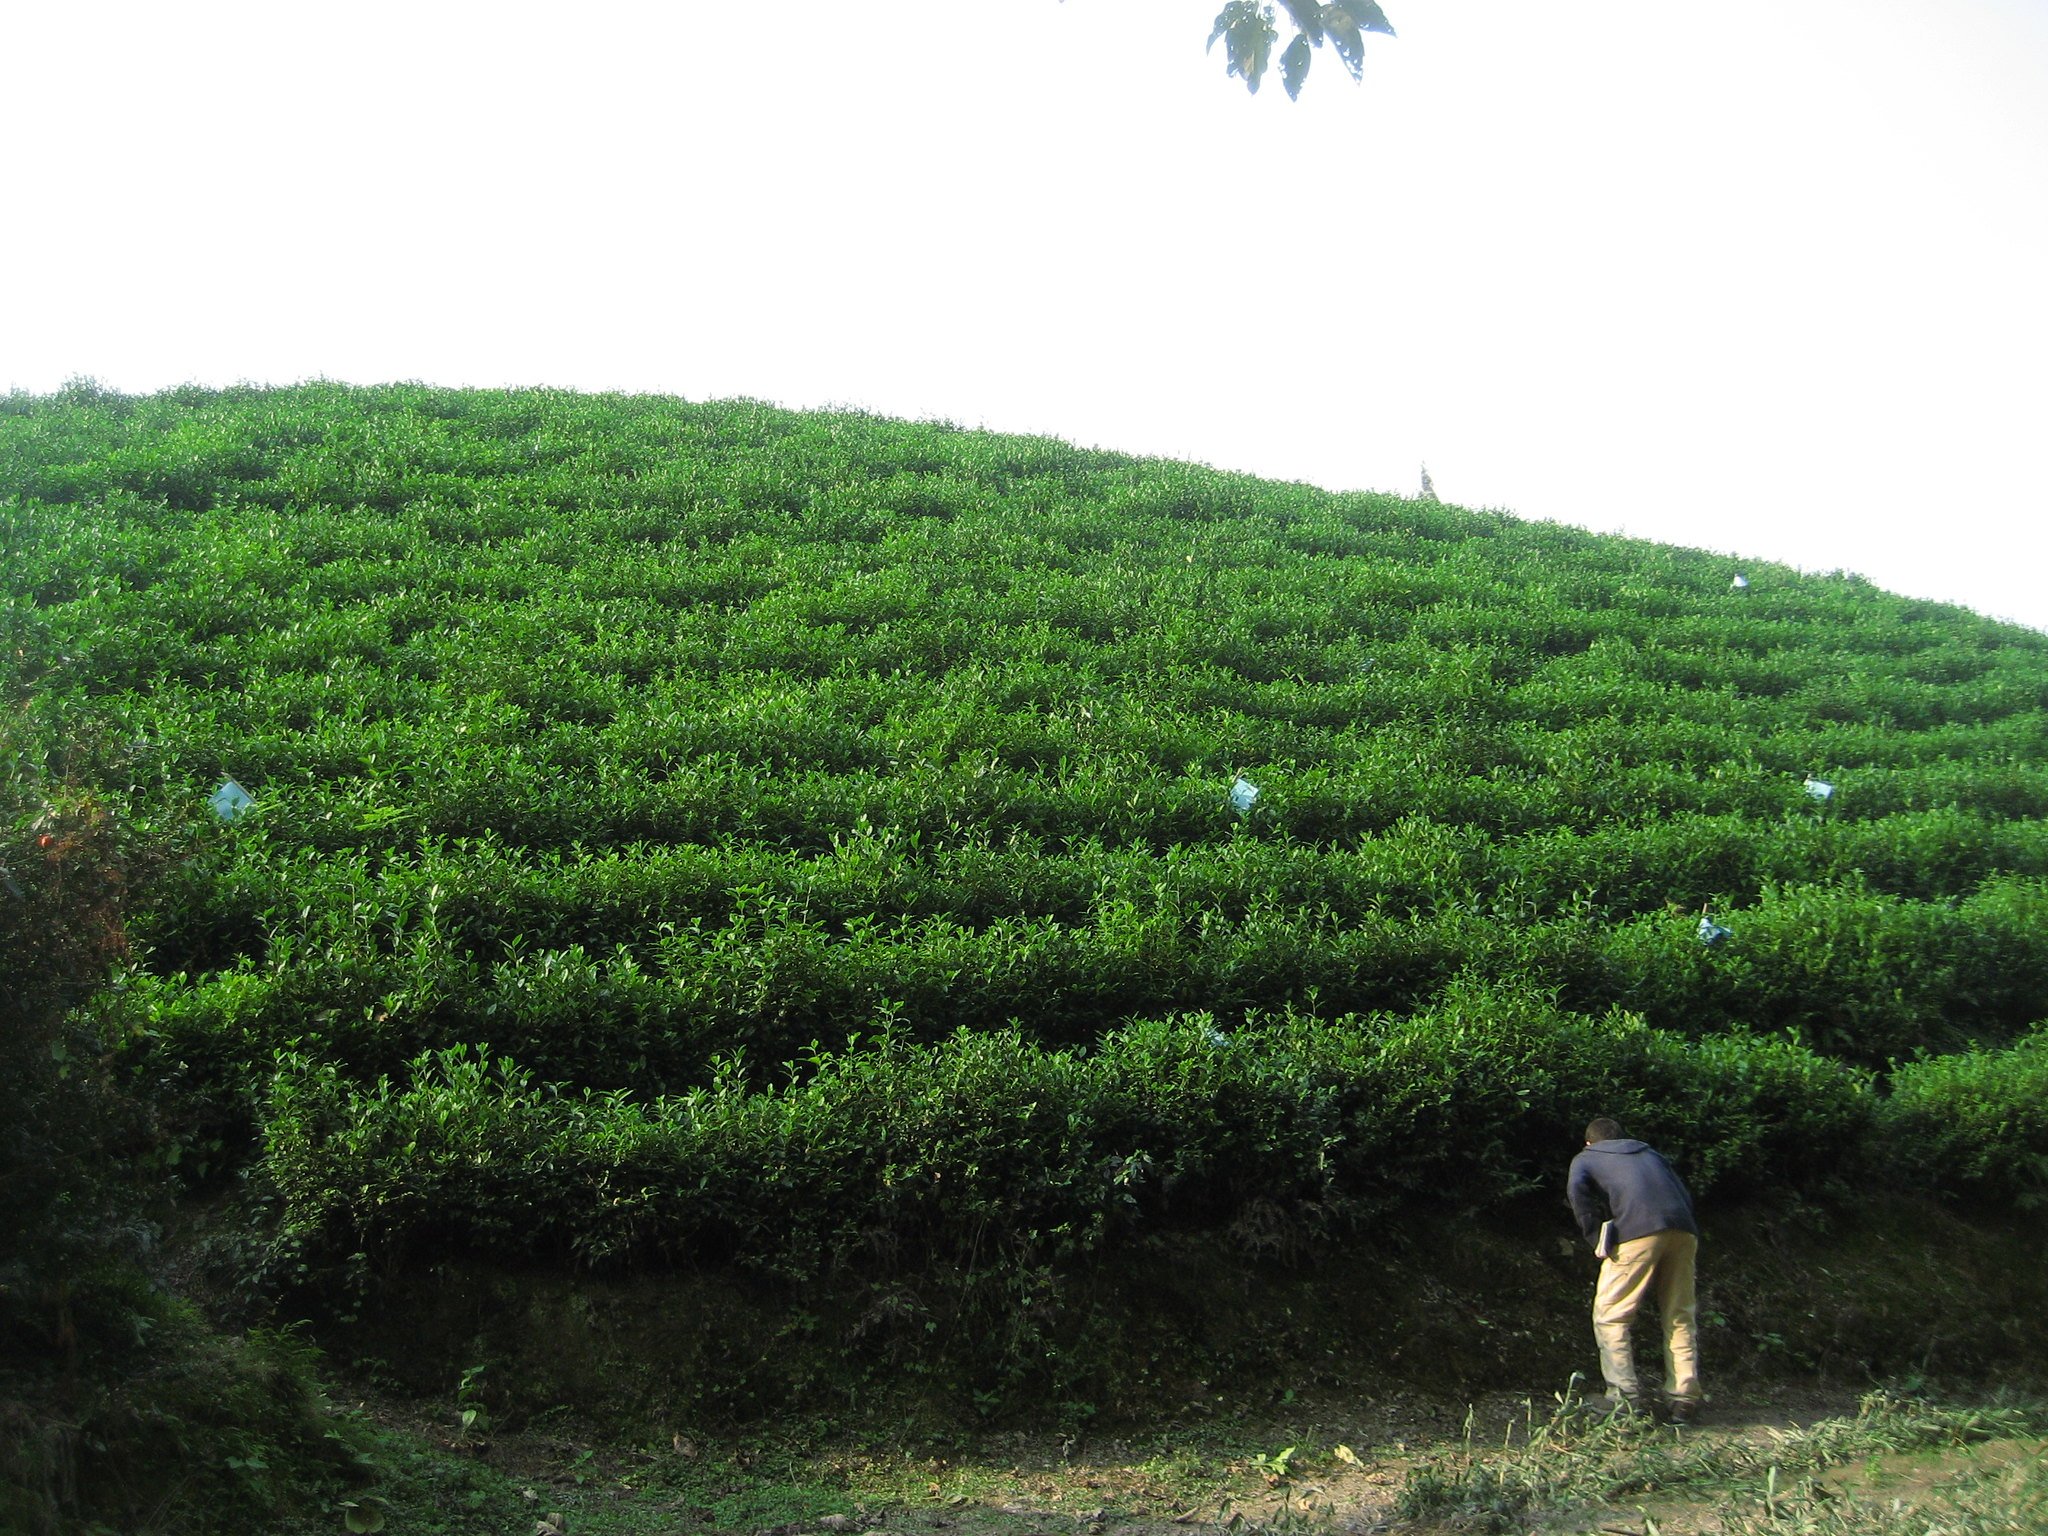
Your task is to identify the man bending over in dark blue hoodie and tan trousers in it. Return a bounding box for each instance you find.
[1565,1116,1702,1423]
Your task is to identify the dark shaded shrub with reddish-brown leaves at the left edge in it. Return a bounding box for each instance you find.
[0,711,360,1536]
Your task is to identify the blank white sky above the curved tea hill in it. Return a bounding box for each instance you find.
[12,0,2048,629]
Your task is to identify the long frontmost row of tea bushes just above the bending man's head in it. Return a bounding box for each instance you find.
[264,989,1870,1302]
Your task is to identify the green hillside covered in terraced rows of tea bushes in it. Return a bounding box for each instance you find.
[0,383,2048,1392]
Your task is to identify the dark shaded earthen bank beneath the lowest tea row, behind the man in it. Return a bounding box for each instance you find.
[268,1192,2048,1436]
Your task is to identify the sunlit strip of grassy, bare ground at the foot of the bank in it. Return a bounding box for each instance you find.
[295,1391,2048,1536]
